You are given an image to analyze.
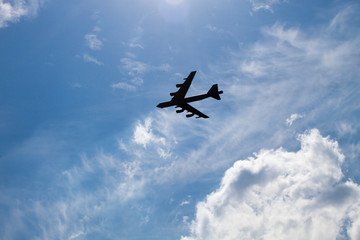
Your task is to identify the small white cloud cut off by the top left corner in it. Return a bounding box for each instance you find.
[0,0,45,28]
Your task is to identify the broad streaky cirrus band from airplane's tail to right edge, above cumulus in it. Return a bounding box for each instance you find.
[143,3,360,186]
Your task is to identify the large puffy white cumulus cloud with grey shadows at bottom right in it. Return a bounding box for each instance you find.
[182,129,360,240]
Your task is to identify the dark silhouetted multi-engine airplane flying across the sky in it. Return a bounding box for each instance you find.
[157,71,223,118]
